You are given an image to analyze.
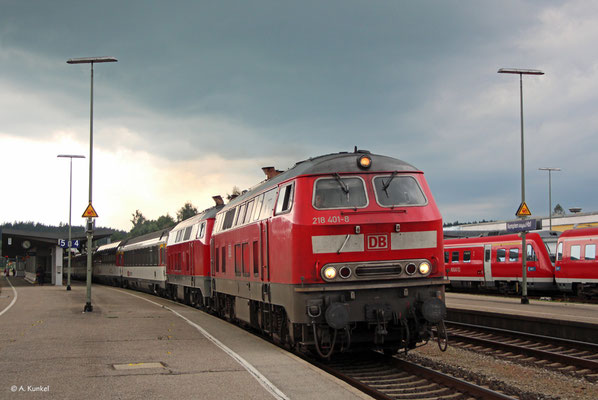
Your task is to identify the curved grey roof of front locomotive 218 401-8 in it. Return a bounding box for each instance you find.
[226,150,421,208]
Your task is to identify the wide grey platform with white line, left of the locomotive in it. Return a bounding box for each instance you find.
[0,277,370,400]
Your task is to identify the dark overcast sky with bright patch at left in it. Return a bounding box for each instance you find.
[0,0,598,231]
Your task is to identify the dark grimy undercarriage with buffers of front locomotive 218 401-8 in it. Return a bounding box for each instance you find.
[211,281,445,358]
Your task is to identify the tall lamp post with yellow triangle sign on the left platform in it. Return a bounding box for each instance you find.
[66,57,118,312]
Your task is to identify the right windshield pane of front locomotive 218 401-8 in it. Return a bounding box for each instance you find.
[374,173,426,207]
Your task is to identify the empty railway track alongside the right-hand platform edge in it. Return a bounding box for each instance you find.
[446,322,598,382]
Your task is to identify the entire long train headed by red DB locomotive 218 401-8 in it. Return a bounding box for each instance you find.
[76,149,447,357]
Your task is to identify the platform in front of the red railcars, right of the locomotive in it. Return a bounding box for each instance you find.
[446,292,598,343]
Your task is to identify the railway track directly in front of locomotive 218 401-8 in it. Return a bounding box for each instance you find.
[310,352,513,400]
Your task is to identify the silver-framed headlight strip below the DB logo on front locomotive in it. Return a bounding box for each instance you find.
[321,259,432,282]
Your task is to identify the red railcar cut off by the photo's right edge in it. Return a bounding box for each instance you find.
[555,228,598,296]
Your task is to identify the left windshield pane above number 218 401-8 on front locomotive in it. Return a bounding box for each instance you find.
[313,175,368,209]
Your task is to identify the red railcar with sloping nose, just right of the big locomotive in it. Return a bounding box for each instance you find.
[444,232,556,293]
